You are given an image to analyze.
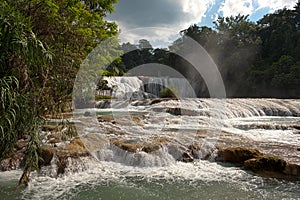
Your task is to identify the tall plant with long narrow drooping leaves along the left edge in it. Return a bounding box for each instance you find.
[0,1,52,185]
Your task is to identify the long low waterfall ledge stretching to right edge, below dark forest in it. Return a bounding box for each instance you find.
[148,99,300,119]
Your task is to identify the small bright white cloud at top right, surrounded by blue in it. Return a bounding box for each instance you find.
[219,0,254,17]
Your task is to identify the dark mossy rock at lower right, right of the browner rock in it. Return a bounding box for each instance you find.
[244,155,287,172]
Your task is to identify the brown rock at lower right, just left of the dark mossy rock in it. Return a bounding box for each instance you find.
[216,147,262,164]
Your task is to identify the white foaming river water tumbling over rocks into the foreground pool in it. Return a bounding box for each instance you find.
[0,98,300,199]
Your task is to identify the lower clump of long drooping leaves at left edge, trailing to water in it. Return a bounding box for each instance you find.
[0,76,41,184]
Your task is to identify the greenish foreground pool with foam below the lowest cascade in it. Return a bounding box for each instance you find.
[0,161,300,200]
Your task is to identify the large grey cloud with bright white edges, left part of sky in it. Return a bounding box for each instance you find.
[108,0,215,47]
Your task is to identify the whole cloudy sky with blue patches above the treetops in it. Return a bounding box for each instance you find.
[107,0,298,48]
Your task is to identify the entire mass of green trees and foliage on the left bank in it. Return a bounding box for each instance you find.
[0,0,118,184]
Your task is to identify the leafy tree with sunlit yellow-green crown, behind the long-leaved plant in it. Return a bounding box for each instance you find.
[11,0,118,113]
